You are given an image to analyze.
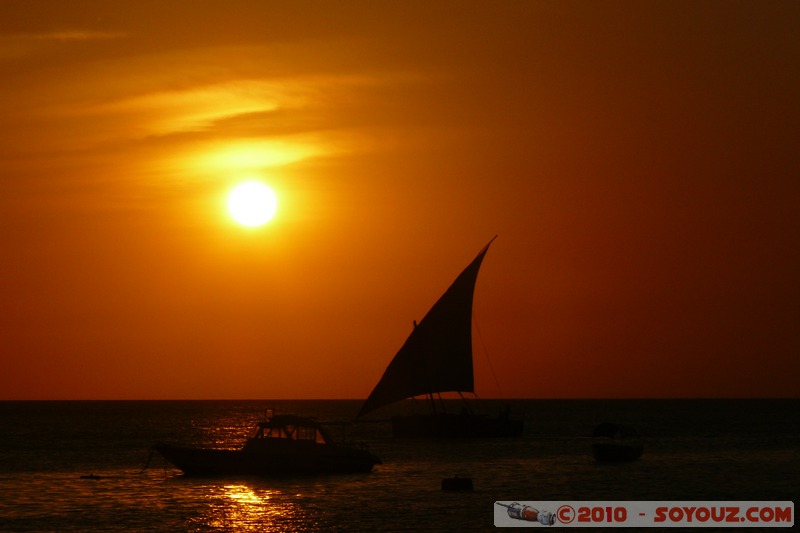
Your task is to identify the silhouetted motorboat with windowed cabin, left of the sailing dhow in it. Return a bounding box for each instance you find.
[153,415,382,476]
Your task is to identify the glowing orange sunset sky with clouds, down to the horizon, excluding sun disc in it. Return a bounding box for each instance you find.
[0,0,800,399]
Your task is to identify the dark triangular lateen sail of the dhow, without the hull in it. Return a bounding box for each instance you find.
[357,239,494,418]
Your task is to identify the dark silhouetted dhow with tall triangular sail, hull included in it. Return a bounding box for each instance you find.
[356,239,523,438]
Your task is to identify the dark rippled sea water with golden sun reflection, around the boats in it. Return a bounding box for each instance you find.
[0,400,800,532]
